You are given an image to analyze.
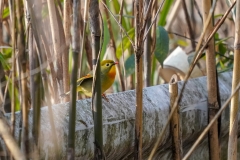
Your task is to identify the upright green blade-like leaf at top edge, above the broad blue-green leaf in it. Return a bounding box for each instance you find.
[158,0,173,26]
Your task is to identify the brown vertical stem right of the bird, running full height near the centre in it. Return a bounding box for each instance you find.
[134,0,143,160]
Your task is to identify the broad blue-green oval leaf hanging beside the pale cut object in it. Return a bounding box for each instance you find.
[154,26,169,66]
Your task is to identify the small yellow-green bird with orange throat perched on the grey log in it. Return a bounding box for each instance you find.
[60,59,118,98]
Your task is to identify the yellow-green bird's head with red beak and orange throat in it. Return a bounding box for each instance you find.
[101,59,118,78]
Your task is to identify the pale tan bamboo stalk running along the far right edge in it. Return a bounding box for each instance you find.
[228,0,240,160]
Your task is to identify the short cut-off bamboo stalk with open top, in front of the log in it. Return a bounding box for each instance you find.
[169,74,182,160]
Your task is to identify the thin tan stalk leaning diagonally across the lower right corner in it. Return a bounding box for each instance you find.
[182,83,240,160]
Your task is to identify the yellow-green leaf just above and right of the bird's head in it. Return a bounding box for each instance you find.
[116,28,135,59]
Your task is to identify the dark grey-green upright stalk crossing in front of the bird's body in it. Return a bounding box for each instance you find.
[89,0,105,159]
